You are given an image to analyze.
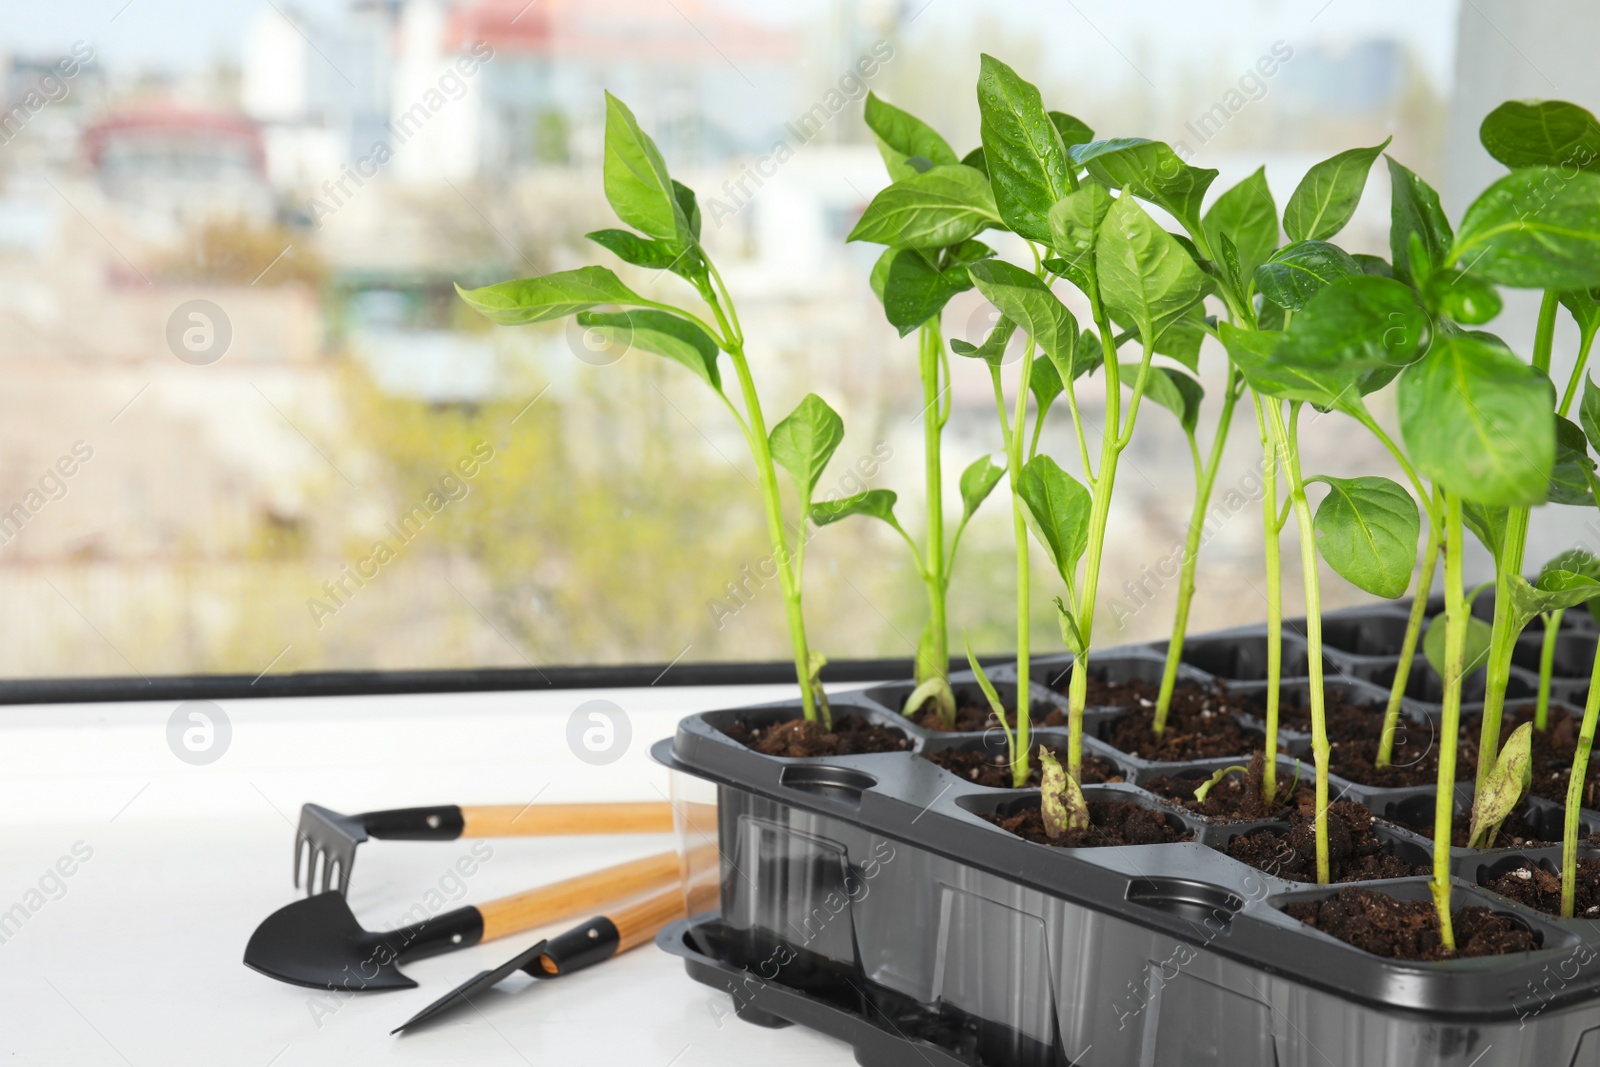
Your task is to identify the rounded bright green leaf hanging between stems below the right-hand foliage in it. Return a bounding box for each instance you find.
[1312,477,1422,600]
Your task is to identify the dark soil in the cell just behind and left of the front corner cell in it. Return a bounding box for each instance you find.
[1226,800,1427,881]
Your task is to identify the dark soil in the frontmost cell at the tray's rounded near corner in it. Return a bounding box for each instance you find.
[1283,886,1539,960]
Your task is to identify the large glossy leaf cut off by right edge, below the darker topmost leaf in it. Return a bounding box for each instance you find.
[1450,166,1600,290]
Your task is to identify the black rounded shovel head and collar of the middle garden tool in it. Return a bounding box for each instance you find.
[245,893,483,993]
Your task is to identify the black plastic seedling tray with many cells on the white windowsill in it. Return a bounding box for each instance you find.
[653,605,1600,1067]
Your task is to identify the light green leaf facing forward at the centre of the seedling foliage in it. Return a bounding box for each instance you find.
[1094,197,1210,351]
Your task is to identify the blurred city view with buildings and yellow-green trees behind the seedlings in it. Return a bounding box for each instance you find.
[0,0,1600,677]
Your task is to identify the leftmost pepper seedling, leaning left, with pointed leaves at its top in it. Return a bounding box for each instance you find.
[456,93,843,728]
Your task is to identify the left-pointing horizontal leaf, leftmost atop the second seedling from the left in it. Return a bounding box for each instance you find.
[845,163,1000,248]
